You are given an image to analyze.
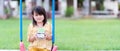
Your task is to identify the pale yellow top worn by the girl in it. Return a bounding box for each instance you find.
[27,23,52,50]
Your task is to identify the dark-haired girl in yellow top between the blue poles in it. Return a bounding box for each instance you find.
[28,6,52,51]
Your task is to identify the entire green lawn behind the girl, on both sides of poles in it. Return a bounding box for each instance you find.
[0,19,120,50]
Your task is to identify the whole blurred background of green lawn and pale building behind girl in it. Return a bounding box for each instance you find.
[0,0,120,50]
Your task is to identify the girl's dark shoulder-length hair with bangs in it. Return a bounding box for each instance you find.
[32,6,47,26]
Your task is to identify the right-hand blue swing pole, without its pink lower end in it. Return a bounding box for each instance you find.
[52,0,55,44]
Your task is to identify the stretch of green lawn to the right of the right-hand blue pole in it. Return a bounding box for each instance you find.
[56,19,120,50]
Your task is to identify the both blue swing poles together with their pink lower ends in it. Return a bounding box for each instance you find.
[20,0,57,51]
